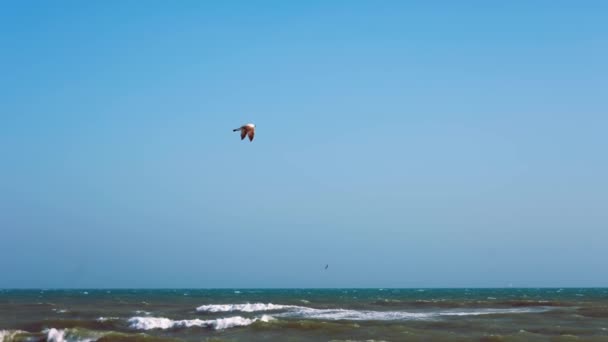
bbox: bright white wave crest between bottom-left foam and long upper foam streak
[128,315,274,330]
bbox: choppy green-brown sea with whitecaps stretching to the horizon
[0,288,608,342]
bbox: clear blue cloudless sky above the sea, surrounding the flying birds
[0,1,608,287]
